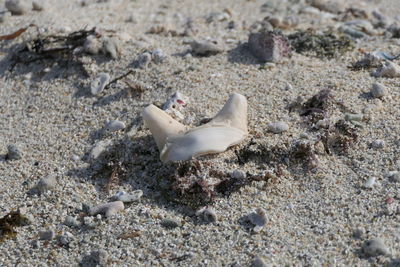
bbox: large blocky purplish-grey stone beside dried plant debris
[248,31,291,63]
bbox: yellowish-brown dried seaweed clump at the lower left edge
[0,210,30,242]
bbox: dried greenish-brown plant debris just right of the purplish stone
[287,31,353,58]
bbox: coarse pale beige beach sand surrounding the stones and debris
[0,0,400,266]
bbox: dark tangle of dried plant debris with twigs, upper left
[12,28,100,71]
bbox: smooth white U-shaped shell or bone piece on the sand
[143,94,247,162]
